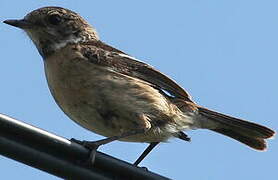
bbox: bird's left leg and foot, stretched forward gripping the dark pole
[71,129,147,164]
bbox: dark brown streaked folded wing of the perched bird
[82,41,192,102]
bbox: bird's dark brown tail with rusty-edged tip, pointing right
[198,107,275,151]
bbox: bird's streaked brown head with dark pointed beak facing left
[4,7,99,57]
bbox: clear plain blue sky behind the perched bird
[0,0,278,180]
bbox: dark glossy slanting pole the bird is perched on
[0,114,172,180]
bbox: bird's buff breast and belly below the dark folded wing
[45,54,192,142]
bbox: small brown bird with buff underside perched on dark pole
[4,6,275,166]
